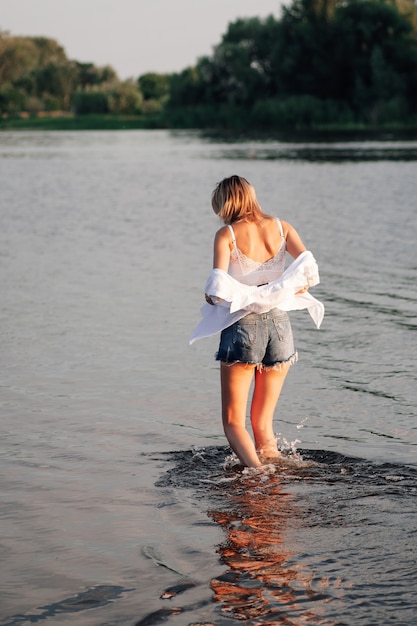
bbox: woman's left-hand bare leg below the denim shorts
[220,363,261,467]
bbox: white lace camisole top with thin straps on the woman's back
[228,218,286,286]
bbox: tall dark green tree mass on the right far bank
[169,0,417,126]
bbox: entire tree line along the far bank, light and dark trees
[0,0,417,130]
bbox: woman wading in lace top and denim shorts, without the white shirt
[206,176,308,467]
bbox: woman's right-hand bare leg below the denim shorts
[251,363,290,457]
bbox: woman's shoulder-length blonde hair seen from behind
[211,176,264,224]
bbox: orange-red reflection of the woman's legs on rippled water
[209,474,334,624]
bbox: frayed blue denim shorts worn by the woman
[216,309,297,367]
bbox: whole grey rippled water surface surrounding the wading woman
[0,131,417,626]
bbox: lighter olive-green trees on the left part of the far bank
[0,32,168,117]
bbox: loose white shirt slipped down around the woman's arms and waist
[190,250,324,344]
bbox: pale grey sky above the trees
[0,0,282,80]
